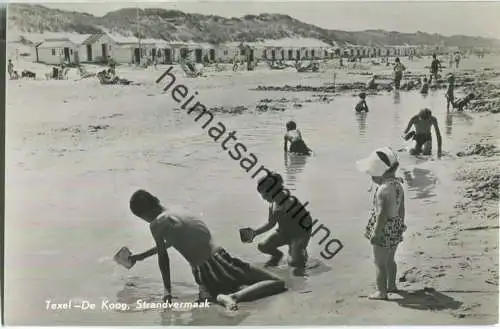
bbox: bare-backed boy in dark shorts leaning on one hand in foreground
[130,190,286,310]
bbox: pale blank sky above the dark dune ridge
[17,0,500,39]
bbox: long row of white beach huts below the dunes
[30,33,435,64]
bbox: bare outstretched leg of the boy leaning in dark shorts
[217,267,286,310]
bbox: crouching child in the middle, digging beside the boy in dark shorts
[246,173,313,276]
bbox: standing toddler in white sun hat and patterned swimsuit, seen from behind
[356,147,406,300]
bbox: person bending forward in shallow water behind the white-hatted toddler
[403,108,442,157]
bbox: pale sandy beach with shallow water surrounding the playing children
[5,50,500,325]
